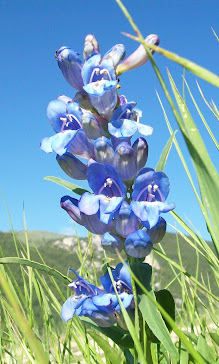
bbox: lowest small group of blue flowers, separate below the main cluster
[61,264,134,327]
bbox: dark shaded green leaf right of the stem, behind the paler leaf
[155,289,175,331]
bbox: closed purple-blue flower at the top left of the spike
[55,46,84,93]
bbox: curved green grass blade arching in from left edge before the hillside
[0,257,71,284]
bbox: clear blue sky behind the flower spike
[0,0,219,238]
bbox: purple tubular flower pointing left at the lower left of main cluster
[60,196,113,235]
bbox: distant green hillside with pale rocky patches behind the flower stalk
[0,231,217,322]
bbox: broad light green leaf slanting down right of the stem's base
[139,291,178,360]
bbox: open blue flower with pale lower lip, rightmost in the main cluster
[131,168,175,229]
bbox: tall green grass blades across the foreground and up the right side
[0,0,219,364]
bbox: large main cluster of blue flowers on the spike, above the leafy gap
[41,34,174,258]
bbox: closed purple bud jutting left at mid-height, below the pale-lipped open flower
[56,152,87,180]
